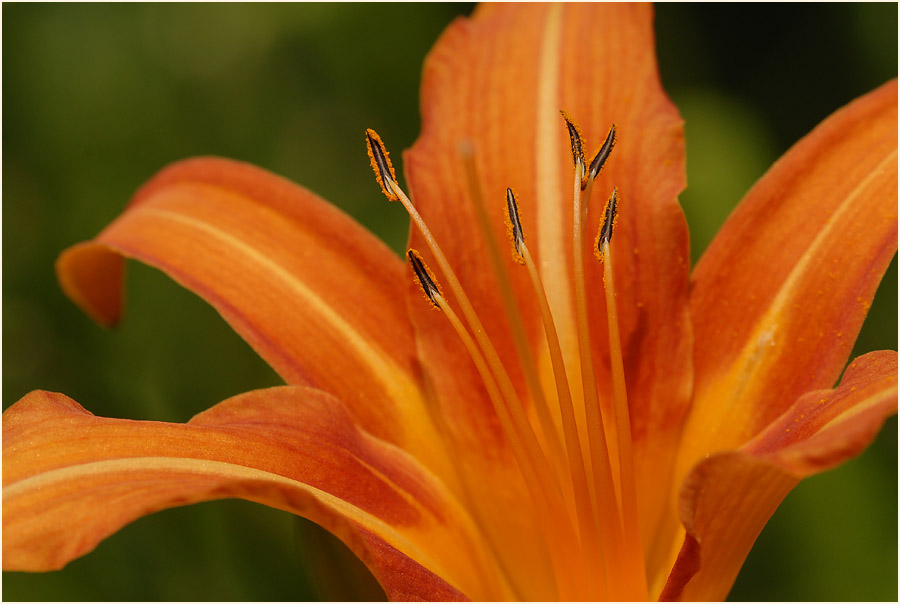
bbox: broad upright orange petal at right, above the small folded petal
[680,81,897,469]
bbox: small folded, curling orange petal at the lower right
[662,351,897,600]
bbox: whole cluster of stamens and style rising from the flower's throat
[366,117,648,600]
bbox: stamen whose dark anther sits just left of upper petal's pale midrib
[506,189,608,600]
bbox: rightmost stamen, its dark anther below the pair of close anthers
[596,189,644,596]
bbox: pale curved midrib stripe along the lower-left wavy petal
[3,457,447,579]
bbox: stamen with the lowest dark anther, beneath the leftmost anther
[407,250,585,600]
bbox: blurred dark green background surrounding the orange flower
[2,4,897,601]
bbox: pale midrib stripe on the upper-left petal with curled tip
[134,208,421,411]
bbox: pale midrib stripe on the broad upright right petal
[708,149,897,408]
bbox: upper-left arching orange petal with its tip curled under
[57,158,452,494]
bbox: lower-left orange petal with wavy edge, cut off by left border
[3,386,509,599]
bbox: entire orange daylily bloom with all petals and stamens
[3,4,897,600]
